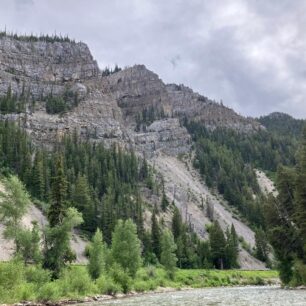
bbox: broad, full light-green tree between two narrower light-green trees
[111,219,142,277]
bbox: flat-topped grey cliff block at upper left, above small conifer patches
[0,37,99,99]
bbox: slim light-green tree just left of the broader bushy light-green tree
[87,229,105,279]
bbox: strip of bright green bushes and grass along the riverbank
[0,260,279,305]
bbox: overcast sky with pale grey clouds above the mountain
[0,0,306,118]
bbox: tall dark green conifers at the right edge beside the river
[265,123,306,284]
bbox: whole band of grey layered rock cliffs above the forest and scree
[0,37,259,155]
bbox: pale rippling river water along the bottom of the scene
[86,286,306,306]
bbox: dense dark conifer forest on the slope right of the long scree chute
[185,122,297,227]
